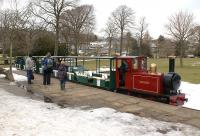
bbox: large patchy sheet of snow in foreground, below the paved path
[0,89,200,136]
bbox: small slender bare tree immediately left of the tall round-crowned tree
[104,18,117,56]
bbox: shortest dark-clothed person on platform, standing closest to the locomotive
[58,61,67,90]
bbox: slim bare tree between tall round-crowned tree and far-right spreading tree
[137,17,148,55]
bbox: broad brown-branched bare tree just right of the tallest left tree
[62,5,95,55]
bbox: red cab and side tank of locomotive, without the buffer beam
[116,57,163,94]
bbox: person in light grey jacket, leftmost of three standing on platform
[25,54,34,92]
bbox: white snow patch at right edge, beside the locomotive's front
[180,82,200,110]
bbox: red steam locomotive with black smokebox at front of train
[116,56,186,105]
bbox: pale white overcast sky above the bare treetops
[0,0,200,38]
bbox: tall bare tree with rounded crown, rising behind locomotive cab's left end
[112,5,134,55]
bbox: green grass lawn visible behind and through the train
[72,58,200,84]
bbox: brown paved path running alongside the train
[3,71,200,128]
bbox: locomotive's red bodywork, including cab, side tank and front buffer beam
[116,56,185,105]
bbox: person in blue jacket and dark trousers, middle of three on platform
[42,52,53,85]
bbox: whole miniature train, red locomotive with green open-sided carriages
[15,56,186,105]
